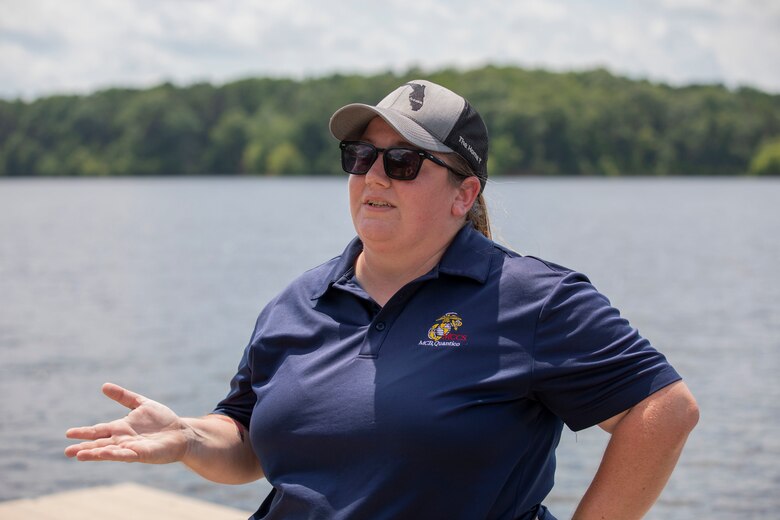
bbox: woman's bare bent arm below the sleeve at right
[573,382,699,520]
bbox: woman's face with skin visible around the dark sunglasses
[349,117,473,252]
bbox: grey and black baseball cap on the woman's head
[330,79,488,193]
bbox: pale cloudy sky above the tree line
[0,0,780,100]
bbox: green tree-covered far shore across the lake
[0,66,780,176]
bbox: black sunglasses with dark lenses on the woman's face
[339,141,452,181]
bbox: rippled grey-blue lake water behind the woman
[0,178,780,520]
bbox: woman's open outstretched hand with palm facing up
[65,383,193,464]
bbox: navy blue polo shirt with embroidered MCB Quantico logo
[215,226,680,520]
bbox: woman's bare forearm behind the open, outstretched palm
[181,414,263,484]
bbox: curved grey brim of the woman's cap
[329,103,453,152]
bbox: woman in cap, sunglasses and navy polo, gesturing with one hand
[66,80,698,519]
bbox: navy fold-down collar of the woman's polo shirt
[311,224,496,300]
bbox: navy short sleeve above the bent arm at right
[531,272,680,431]
